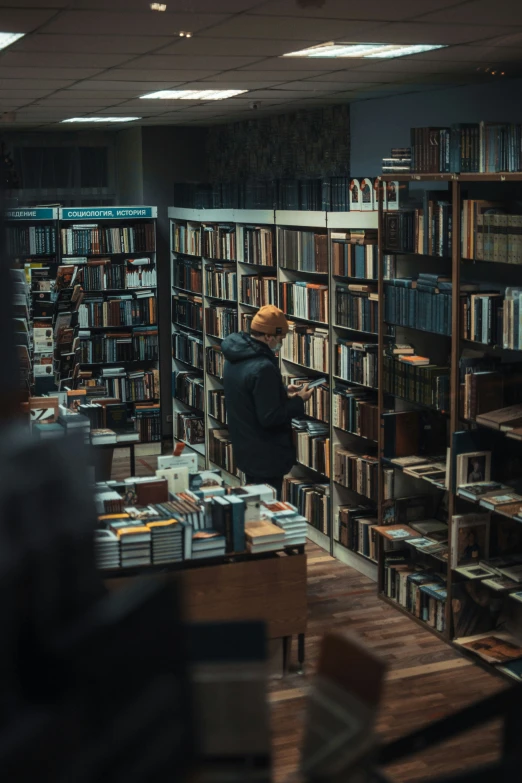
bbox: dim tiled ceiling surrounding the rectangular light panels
[0,0,522,131]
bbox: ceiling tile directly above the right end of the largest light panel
[366,22,508,44]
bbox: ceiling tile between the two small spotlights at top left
[41,10,226,36]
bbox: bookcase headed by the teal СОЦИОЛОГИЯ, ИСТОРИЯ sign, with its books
[59,206,161,443]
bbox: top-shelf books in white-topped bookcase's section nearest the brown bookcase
[331,229,378,280]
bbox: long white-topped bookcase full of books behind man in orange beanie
[169,208,378,568]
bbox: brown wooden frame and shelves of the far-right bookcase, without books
[378,172,522,670]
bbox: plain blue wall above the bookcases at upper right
[350,77,522,177]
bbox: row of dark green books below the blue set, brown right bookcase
[383,356,450,412]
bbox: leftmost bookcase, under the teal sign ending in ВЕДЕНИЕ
[5,207,60,394]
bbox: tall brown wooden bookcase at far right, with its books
[374,173,522,680]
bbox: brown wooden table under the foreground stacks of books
[105,547,307,670]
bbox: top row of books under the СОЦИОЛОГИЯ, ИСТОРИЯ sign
[60,223,156,256]
